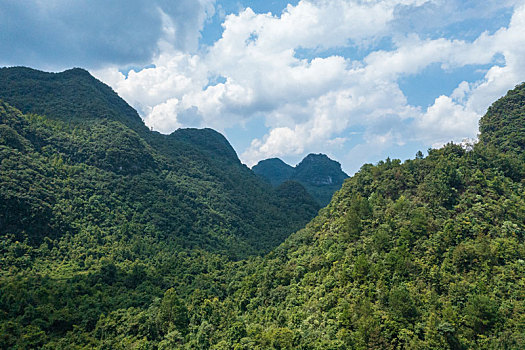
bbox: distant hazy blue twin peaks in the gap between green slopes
[252,154,348,206]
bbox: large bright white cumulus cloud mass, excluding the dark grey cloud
[91,0,525,170]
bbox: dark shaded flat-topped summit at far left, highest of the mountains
[0,67,147,132]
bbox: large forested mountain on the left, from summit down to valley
[0,68,319,348]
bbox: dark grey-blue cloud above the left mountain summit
[0,0,215,70]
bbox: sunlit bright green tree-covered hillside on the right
[171,85,525,349]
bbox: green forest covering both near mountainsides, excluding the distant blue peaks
[0,67,525,350]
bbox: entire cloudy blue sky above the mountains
[0,0,525,174]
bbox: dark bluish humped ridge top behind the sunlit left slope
[0,67,244,167]
